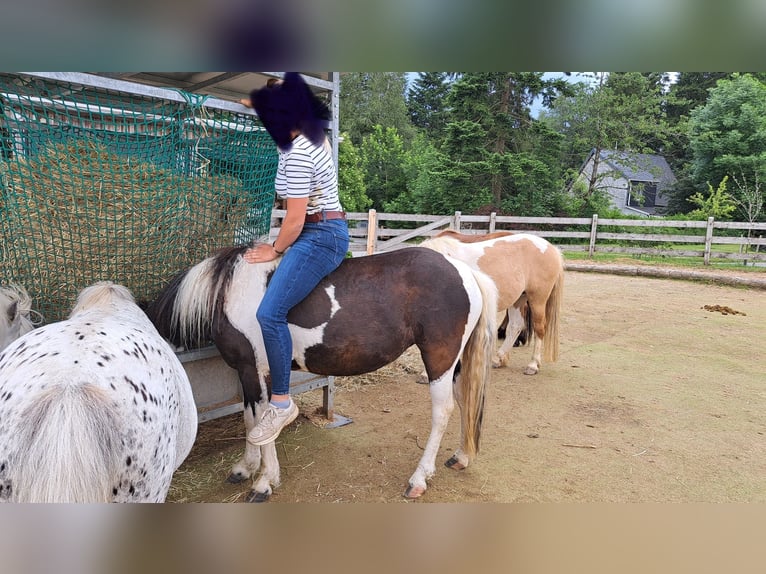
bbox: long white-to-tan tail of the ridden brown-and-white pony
[456,271,497,461]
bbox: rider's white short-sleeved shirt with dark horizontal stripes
[274,135,343,215]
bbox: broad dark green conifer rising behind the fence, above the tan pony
[440,72,569,212]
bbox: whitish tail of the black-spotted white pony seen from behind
[11,383,123,503]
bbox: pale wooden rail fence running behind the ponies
[271,209,766,265]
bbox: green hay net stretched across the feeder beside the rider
[0,74,277,323]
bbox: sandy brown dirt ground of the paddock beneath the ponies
[168,271,766,504]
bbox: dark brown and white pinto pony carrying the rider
[147,247,497,502]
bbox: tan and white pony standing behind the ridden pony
[421,230,564,375]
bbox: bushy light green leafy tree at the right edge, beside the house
[689,74,766,216]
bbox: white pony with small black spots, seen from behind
[0,282,197,502]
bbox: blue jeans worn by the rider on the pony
[256,219,348,395]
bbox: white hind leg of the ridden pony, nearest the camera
[404,369,455,498]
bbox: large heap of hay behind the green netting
[0,140,264,321]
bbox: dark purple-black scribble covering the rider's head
[250,72,332,150]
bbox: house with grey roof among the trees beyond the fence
[578,150,676,216]
